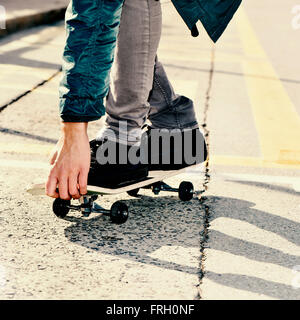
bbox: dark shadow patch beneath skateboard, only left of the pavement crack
[65,196,202,274]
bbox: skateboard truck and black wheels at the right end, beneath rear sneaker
[127,181,195,201]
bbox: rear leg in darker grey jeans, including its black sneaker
[147,60,207,170]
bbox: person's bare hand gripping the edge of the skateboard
[45,123,90,200]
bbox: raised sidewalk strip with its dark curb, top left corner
[0,0,69,38]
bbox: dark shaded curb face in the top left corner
[0,7,66,39]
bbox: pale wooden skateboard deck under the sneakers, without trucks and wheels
[27,164,198,196]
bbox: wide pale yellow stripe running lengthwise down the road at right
[237,8,300,165]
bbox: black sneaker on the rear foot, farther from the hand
[142,127,207,171]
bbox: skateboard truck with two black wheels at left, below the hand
[52,195,128,224]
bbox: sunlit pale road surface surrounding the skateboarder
[0,0,300,299]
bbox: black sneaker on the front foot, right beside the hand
[88,140,148,188]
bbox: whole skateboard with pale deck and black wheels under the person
[27,165,197,224]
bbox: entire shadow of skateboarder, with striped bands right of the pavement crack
[65,184,300,299]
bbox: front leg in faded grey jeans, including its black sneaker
[89,0,162,186]
